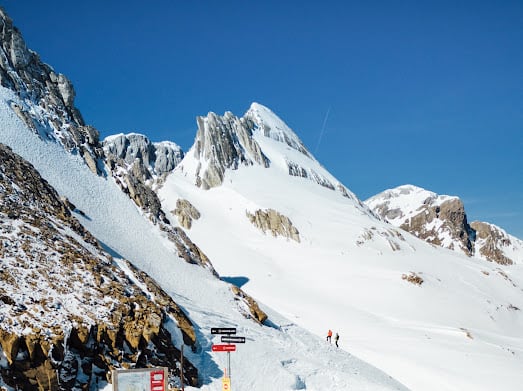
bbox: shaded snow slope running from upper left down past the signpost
[0,88,405,390]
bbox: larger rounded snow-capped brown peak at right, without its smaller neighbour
[365,185,474,255]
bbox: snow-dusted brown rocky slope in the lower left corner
[0,144,198,390]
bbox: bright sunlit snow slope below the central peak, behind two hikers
[159,105,523,391]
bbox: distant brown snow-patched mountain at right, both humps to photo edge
[365,185,523,265]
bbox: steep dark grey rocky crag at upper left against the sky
[0,8,101,173]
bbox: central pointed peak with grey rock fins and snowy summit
[184,103,357,200]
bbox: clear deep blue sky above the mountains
[4,0,523,238]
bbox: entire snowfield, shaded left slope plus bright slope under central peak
[0,88,523,391]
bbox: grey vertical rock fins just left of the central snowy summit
[193,112,269,189]
